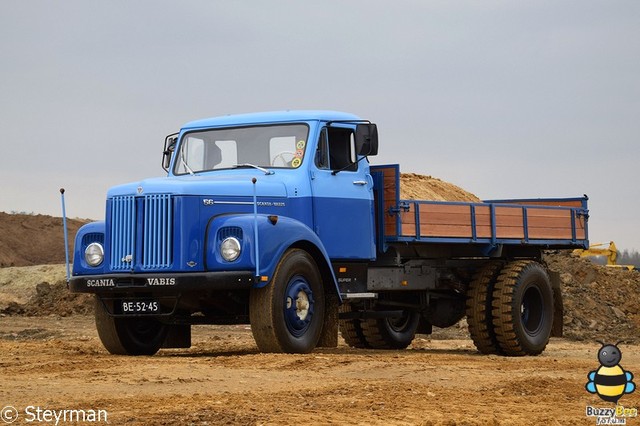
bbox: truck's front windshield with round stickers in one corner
[173,124,309,175]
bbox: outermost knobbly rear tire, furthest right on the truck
[492,260,553,356]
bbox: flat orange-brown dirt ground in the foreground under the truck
[0,315,640,425]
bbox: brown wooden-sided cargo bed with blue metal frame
[371,164,588,248]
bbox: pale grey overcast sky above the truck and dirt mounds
[0,0,640,250]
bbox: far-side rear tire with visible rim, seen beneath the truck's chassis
[361,311,420,349]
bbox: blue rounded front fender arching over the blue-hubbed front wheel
[204,214,338,292]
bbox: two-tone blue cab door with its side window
[310,125,376,260]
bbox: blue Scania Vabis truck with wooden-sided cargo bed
[69,111,589,356]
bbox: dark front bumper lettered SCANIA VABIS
[69,271,256,294]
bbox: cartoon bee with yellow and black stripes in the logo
[585,340,636,404]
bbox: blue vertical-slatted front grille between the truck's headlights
[110,194,173,271]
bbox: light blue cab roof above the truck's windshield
[182,110,362,129]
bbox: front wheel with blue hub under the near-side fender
[249,249,325,353]
